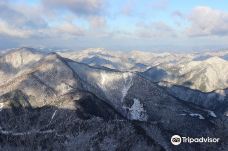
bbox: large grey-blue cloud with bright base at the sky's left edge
[0,1,84,39]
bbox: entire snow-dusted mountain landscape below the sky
[0,48,228,151]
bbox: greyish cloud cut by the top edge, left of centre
[42,0,105,16]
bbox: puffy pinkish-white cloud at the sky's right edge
[186,6,228,36]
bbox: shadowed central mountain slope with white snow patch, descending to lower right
[62,56,228,149]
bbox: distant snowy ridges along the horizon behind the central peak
[59,48,190,71]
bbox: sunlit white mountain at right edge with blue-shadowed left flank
[144,57,228,92]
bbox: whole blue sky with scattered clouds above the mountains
[0,0,228,52]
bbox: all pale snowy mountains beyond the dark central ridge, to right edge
[59,48,228,92]
